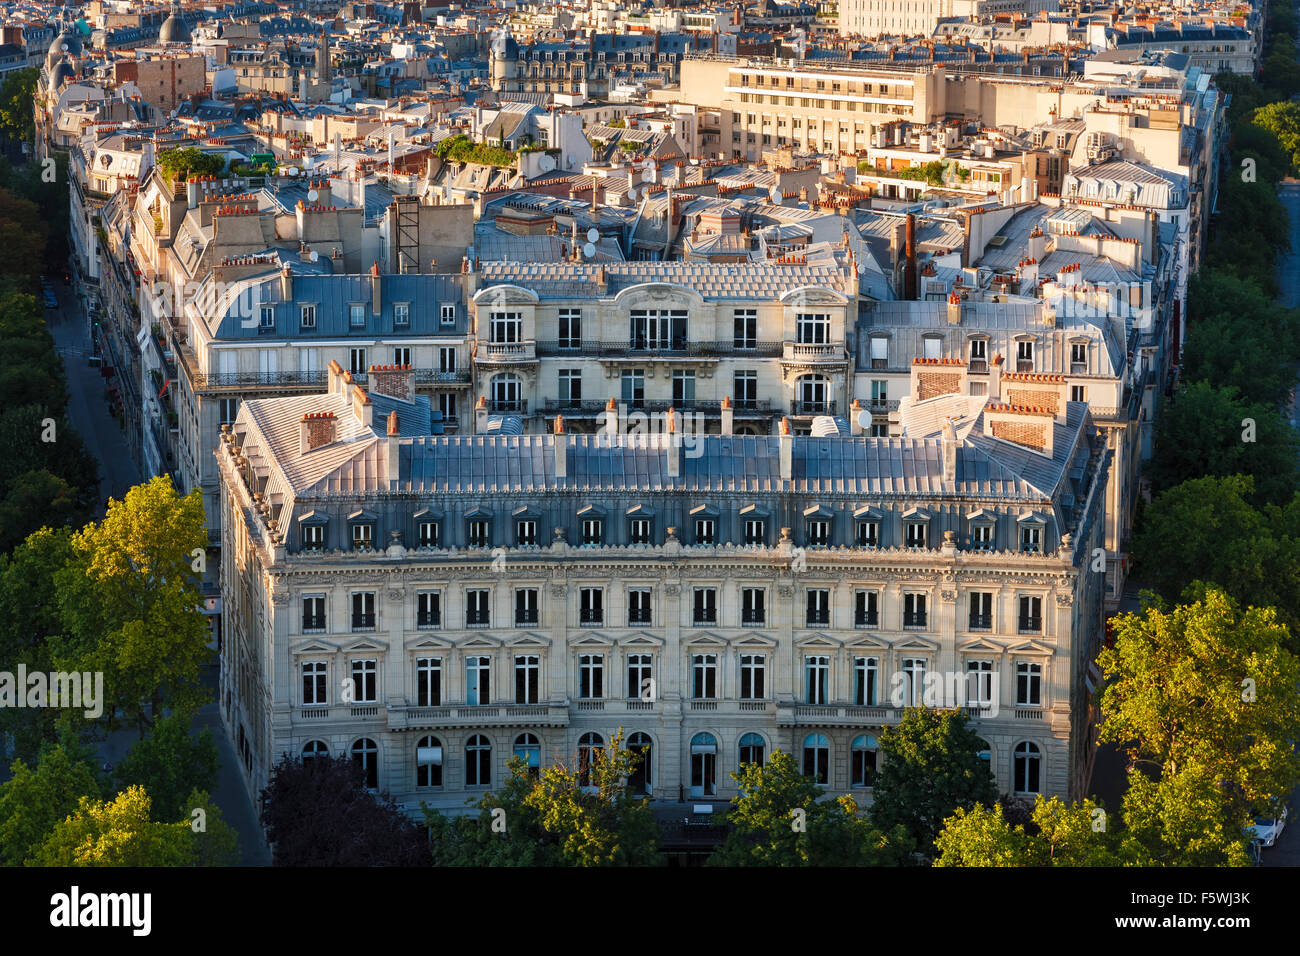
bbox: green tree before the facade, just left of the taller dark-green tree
[709,750,911,866]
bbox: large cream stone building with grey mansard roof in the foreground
[216,364,1108,813]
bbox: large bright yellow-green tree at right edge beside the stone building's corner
[1097,588,1300,831]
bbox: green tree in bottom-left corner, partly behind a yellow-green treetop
[0,745,100,866]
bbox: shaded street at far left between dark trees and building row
[46,282,142,516]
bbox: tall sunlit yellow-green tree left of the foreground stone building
[55,476,212,739]
